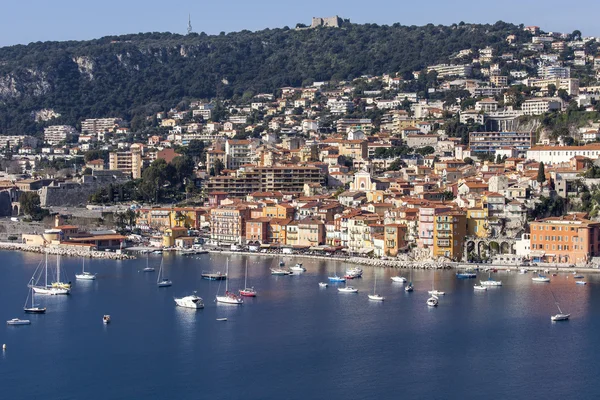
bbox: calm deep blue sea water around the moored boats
[0,252,600,400]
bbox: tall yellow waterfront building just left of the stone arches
[433,211,467,261]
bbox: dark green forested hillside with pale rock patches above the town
[0,22,528,134]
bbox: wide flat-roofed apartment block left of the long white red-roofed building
[469,132,535,155]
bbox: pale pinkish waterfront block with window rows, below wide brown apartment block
[210,205,250,245]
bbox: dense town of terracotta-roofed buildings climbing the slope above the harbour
[0,19,600,266]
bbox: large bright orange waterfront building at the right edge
[530,215,600,264]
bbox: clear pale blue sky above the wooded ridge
[0,0,600,47]
